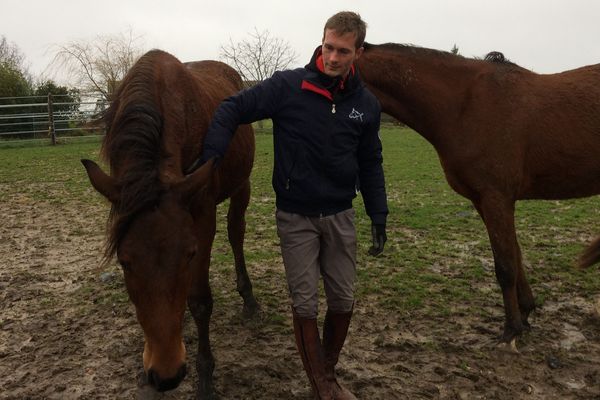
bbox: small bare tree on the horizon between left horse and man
[220,28,298,85]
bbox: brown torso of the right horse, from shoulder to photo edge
[446,65,600,199]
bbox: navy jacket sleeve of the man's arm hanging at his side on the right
[358,102,388,224]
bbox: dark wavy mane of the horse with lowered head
[99,51,164,262]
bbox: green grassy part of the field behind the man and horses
[0,126,600,322]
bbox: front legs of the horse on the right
[476,196,531,343]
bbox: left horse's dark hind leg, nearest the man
[227,181,259,317]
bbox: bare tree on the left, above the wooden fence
[51,30,144,100]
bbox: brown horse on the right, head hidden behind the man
[358,44,600,345]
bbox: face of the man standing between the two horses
[322,29,363,78]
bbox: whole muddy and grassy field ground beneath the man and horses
[0,126,600,400]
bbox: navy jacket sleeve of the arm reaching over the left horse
[201,72,282,161]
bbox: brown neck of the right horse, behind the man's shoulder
[361,47,477,145]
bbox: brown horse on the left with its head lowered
[82,50,258,399]
